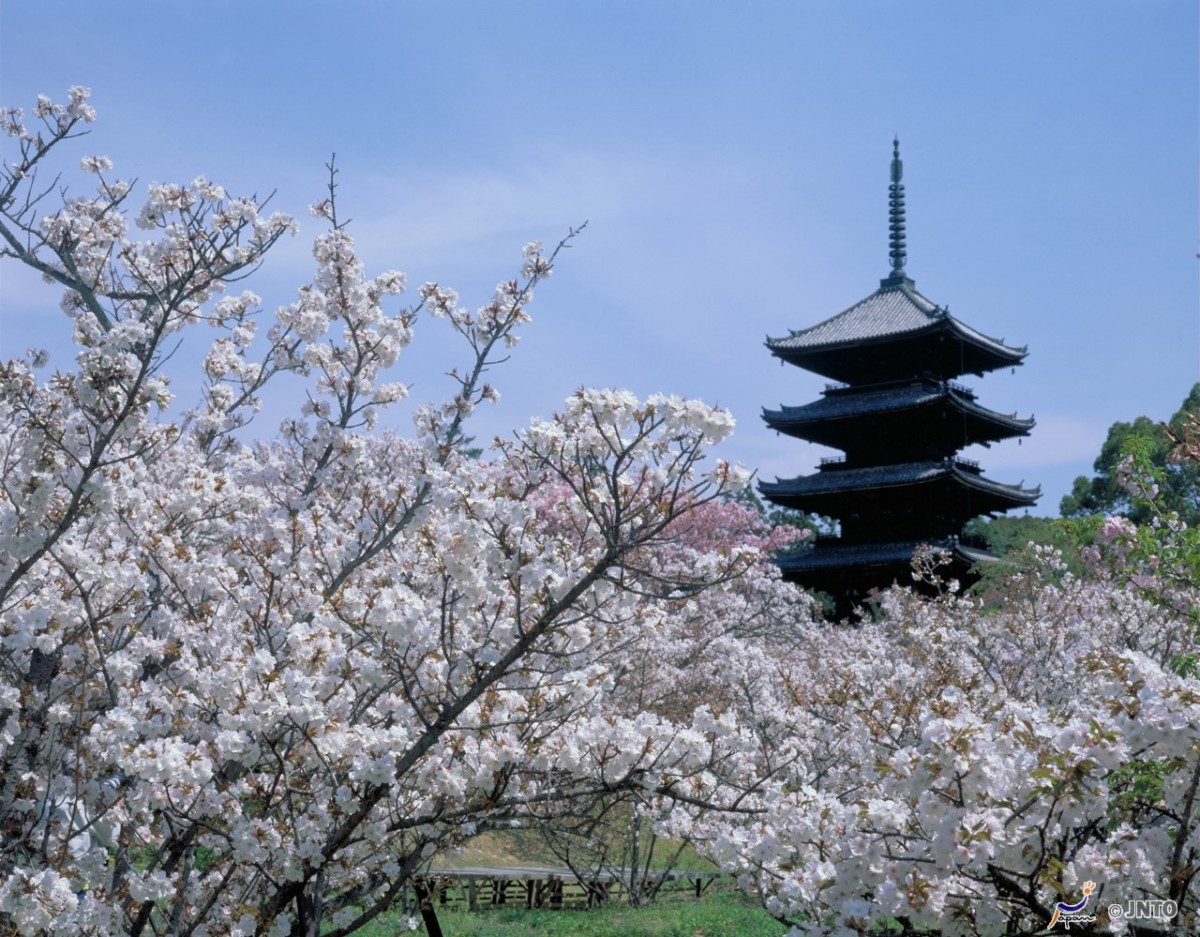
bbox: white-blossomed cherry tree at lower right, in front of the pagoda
[686,529,1200,937]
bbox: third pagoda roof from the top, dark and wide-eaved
[758,458,1042,517]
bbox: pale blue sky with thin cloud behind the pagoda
[0,0,1200,515]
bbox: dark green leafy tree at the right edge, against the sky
[1060,384,1200,525]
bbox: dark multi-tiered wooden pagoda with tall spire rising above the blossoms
[758,139,1040,614]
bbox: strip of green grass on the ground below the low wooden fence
[350,891,786,937]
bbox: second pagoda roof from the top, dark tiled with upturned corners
[762,380,1034,448]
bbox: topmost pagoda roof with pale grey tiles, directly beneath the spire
[767,276,1028,380]
